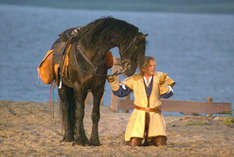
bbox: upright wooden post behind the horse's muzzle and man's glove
[110,57,120,112]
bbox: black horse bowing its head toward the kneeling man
[52,17,147,146]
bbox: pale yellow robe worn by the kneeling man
[110,72,174,142]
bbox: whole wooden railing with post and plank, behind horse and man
[110,58,232,114]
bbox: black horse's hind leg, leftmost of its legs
[58,85,75,142]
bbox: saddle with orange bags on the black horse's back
[37,27,113,86]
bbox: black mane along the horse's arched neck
[81,17,138,49]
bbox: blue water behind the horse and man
[0,5,234,115]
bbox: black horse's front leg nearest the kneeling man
[89,86,104,146]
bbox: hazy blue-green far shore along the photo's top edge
[0,0,234,14]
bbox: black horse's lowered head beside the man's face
[120,32,148,76]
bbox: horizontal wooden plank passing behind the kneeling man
[119,99,232,114]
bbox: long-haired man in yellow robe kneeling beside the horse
[107,57,175,146]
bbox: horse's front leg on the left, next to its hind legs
[74,85,88,145]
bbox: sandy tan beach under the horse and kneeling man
[0,101,234,157]
